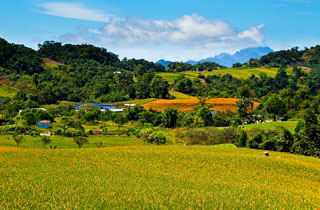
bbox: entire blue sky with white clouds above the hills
[0,0,320,61]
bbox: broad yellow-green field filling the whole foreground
[0,146,320,209]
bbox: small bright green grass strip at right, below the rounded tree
[244,121,298,133]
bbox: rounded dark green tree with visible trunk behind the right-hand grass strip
[265,94,286,121]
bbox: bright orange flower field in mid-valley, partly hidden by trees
[143,98,259,112]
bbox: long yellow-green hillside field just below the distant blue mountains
[159,68,292,84]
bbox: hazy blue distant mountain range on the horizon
[157,47,274,67]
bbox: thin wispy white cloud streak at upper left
[38,2,112,22]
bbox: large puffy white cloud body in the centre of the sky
[102,14,233,44]
